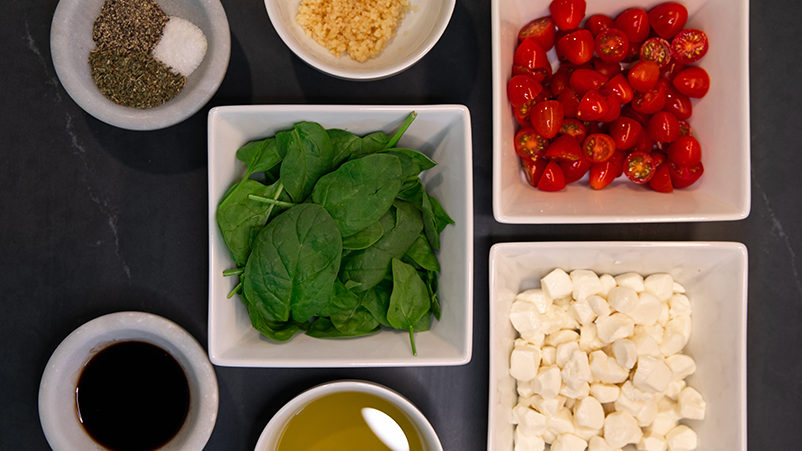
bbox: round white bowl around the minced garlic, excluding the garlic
[265,0,456,81]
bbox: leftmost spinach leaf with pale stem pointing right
[216,179,282,266]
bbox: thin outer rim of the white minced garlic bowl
[264,0,456,81]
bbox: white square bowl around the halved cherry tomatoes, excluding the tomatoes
[491,0,750,224]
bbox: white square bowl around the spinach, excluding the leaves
[208,105,473,367]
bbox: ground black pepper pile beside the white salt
[92,0,168,53]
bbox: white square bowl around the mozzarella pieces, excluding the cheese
[487,242,747,451]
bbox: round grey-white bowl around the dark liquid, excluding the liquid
[39,312,218,451]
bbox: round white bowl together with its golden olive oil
[255,380,443,451]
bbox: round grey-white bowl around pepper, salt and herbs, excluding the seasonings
[50,0,231,130]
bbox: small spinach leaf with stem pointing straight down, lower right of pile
[387,258,431,355]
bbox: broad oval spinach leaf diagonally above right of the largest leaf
[312,154,401,236]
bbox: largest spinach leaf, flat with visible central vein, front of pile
[242,204,342,323]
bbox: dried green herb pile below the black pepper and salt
[89,49,187,109]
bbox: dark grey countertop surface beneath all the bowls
[0,0,802,450]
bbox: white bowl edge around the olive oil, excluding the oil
[254,380,443,451]
